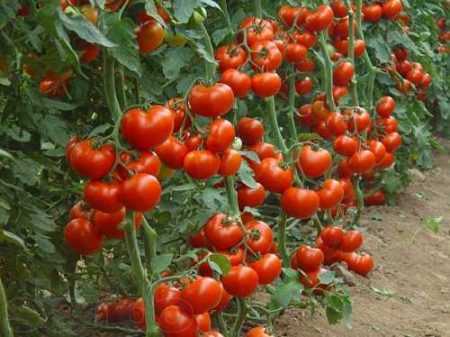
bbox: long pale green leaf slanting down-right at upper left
[57,6,116,47]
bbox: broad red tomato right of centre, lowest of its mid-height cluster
[281,187,320,219]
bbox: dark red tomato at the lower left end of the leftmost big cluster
[64,218,103,255]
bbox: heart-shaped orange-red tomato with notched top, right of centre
[297,145,332,178]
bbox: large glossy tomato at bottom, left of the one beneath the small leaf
[181,277,222,315]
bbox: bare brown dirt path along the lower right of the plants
[277,138,450,337]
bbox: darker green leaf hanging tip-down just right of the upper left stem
[107,15,141,74]
